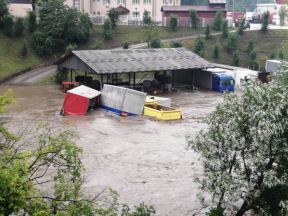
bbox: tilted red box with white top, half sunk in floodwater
[63,85,101,115]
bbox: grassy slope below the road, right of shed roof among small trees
[177,30,288,69]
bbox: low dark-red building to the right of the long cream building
[162,0,227,27]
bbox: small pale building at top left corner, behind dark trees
[8,0,32,17]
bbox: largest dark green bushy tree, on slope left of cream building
[33,0,92,55]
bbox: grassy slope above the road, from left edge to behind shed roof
[0,26,203,80]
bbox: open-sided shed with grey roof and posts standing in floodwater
[57,48,214,88]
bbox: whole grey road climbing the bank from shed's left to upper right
[5,24,288,84]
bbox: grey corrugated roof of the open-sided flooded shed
[58,48,213,74]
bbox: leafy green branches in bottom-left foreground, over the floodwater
[0,91,155,216]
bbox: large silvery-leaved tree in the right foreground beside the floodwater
[189,67,288,216]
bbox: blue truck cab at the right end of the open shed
[212,72,235,92]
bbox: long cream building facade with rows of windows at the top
[66,0,181,22]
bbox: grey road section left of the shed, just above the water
[4,65,57,84]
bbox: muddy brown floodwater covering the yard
[0,86,222,216]
